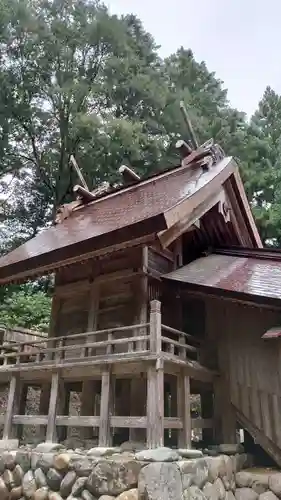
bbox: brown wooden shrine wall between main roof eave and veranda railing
[50,246,173,340]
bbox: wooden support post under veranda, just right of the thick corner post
[177,371,191,448]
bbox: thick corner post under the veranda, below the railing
[147,360,164,448]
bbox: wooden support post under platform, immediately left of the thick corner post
[99,368,111,446]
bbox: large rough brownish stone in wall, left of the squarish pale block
[87,460,142,496]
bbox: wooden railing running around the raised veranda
[0,301,198,370]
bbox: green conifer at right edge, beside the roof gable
[241,87,281,246]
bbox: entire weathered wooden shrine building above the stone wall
[0,143,281,463]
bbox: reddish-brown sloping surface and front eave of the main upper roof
[0,158,237,284]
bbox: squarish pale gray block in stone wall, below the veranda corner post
[138,463,183,500]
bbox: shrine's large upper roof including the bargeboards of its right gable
[0,157,260,284]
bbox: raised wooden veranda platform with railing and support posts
[0,301,215,447]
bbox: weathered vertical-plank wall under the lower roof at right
[205,299,281,462]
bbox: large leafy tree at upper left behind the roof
[0,0,166,244]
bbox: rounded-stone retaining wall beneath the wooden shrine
[0,443,276,500]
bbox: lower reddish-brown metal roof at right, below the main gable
[164,250,281,300]
